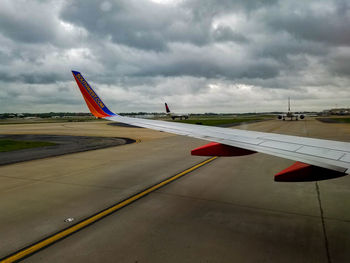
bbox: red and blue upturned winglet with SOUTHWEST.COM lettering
[72,70,116,118]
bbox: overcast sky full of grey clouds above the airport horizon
[0,0,350,112]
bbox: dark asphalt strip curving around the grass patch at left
[0,134,135,165]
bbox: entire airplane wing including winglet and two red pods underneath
[72,71,350,182]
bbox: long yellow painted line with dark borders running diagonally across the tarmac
[1,156,217,263]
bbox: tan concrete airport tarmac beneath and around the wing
[0,119,350,262]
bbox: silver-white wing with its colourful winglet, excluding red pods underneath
[72,71,350,176]
